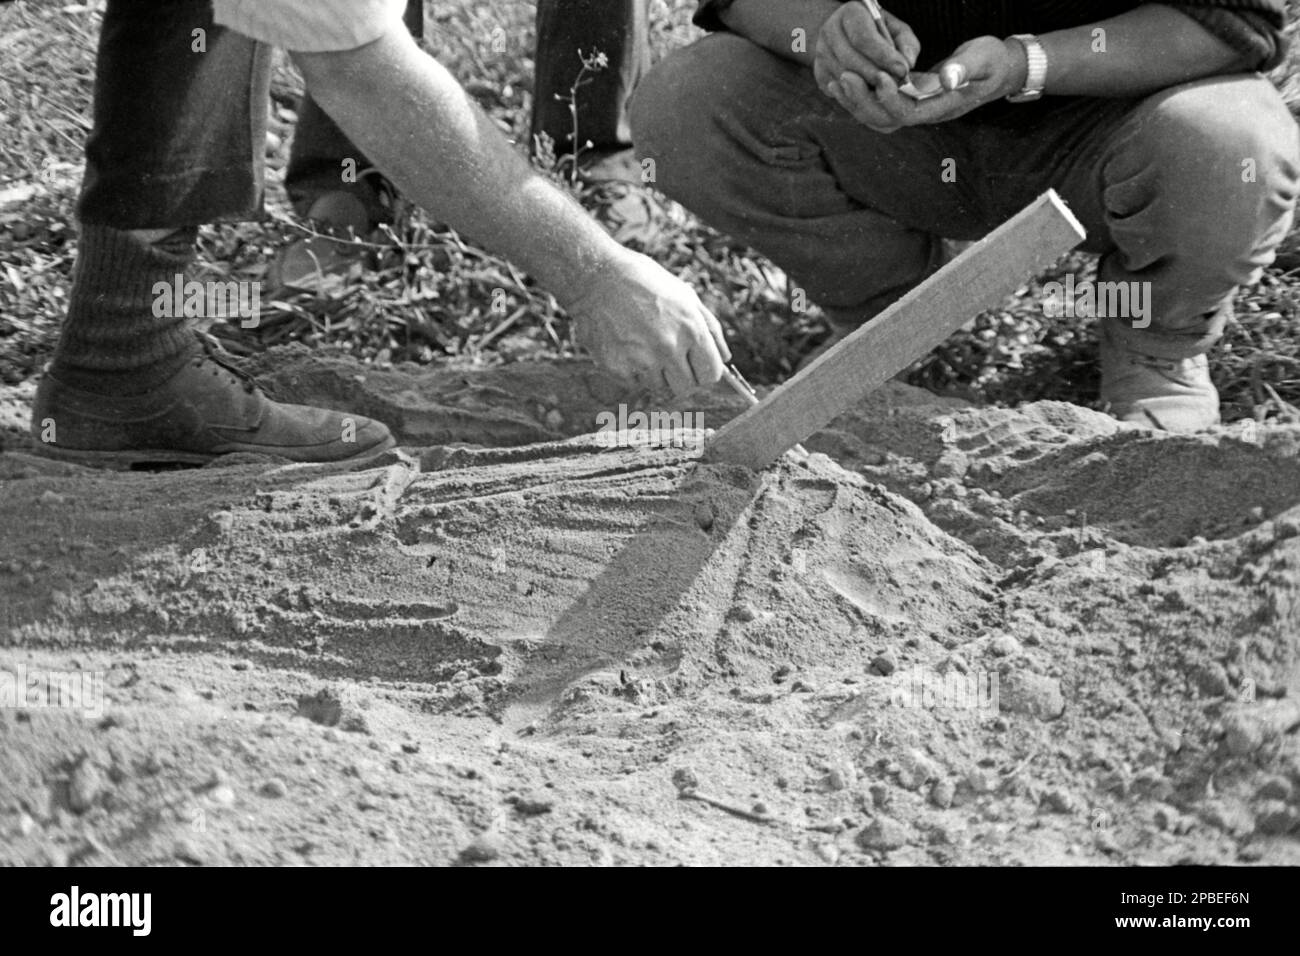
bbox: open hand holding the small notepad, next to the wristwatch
[836,36,1027,133]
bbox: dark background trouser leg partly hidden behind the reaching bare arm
[285,0,424,220]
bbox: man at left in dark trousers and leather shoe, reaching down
[33,0,729,467]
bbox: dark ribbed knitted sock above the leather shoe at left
[51,225,200,395]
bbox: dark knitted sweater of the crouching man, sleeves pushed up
[696,0,1286,69]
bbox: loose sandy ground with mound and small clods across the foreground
[0,350,1300,865]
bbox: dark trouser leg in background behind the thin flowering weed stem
[532,0,650,155]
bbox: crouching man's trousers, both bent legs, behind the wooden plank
[633,34,1300,358]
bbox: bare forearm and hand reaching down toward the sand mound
[294,29,728,393]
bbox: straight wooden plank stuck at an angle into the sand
[705,190,1087,471]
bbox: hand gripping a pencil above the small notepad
[813,3,920,131]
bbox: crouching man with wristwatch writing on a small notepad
[632,0,1300,432]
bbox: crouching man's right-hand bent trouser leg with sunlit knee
[1049,74,1300,358]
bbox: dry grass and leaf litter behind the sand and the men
[0,0,1300,418]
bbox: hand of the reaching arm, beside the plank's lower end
[563,250,731,395]
